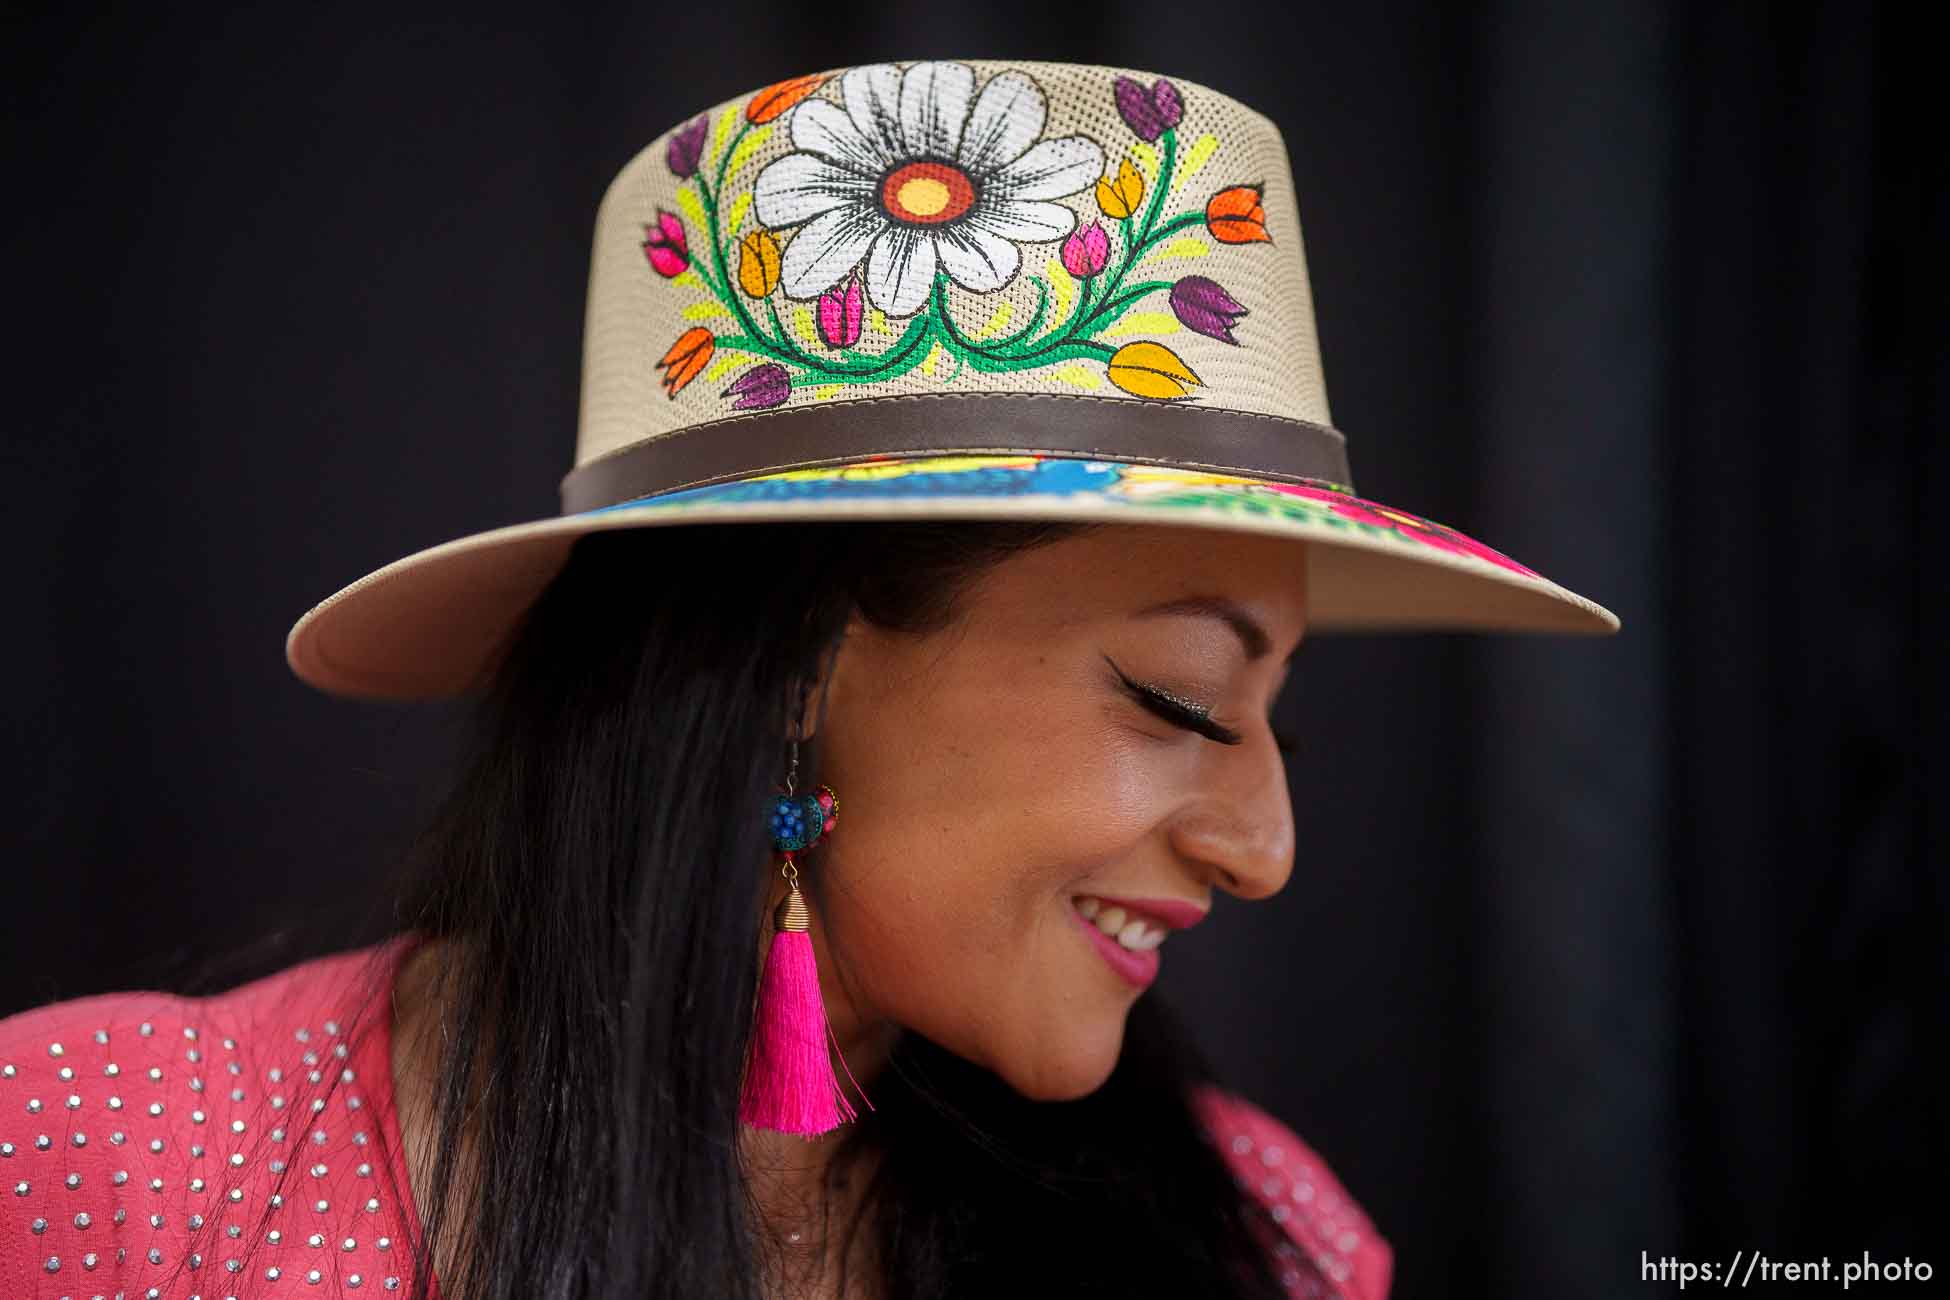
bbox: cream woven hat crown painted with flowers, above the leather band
[575,58,1332,485]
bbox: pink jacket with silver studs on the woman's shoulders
[0,936,1394,1300]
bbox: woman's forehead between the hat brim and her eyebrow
[947,524,1307,639]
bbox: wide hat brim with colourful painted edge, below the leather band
[285,454,1619,700]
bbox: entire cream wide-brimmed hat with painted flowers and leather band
[287,58,1619,698]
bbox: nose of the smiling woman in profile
[1170,731,1293,899]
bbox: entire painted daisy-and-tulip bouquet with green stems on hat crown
[644,62,1271,411]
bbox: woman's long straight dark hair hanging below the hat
[205,520,1285,1300]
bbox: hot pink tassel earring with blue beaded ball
[739,741,874,1138]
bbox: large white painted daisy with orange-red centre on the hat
[753,62,1104,316]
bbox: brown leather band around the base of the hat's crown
[562,394,1353,515]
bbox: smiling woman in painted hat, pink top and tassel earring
[0,62,1617,1300]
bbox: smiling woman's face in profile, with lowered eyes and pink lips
[760,526,1307,1101]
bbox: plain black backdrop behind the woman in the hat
[0,0,1950,1296]
